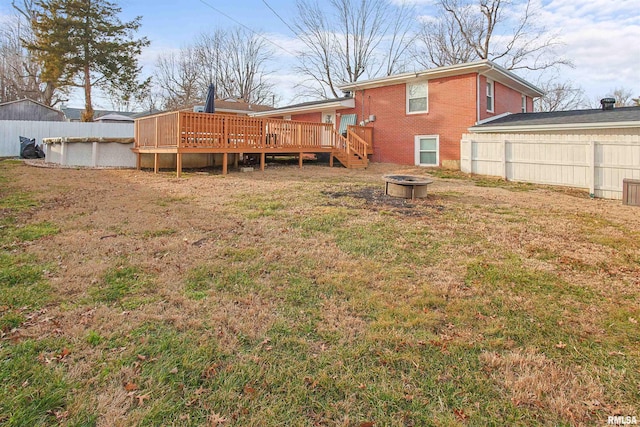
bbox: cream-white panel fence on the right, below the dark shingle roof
[460,133,640,199]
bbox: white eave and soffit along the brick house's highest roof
[340,60,544,98]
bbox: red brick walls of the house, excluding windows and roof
[292,73,531,165]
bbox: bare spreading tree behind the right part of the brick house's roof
[421,0,570,71]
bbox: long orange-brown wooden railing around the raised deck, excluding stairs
[135,111,340,151]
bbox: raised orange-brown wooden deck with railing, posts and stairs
[133,111,373,176]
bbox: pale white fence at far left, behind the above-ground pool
[0,120,133,157]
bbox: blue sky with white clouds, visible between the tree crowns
[0,0,640,107]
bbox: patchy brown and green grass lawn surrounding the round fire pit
[0,161,640,427]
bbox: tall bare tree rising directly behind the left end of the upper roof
[295,0,414,98]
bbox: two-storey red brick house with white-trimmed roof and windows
[253,61,543,169]
